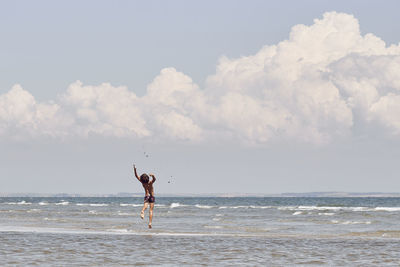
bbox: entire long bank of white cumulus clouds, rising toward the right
[0,12,400,144]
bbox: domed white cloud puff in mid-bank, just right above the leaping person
[141,68,204,141]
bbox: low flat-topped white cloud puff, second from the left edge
[61,81,151,138]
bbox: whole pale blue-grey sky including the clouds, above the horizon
[0,0,400,194]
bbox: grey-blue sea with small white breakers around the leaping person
[0,197,400,266]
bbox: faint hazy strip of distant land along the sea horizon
[0,192,400,198]
